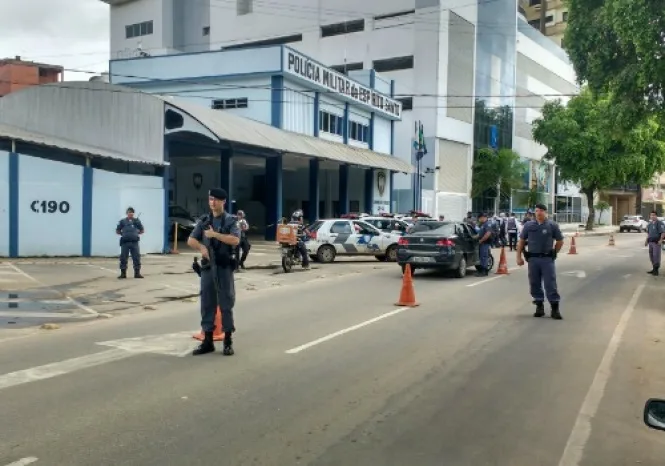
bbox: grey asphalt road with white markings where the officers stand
[0,235,665,466]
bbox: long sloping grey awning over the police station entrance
[162,97,414,173]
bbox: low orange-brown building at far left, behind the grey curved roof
[0,57,64,97]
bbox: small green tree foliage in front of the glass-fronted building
[471,148,525,197]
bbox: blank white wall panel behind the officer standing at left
[91,169,164,256]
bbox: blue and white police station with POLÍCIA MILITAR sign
[0,46,412,257]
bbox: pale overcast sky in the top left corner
[0,0,109,81]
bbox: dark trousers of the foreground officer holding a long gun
[201,267,236,333]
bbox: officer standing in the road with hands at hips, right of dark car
[517,204,563,320]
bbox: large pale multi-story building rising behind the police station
[102,0,574,217]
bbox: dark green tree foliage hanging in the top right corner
[563,0,665,122]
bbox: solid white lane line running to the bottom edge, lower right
[559,284,645,466]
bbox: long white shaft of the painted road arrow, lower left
[0,348,135,390]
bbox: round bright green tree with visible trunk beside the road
[533,89,665,230]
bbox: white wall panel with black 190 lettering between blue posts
[18,154,83,256]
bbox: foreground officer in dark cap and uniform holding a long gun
[187,188,240,356]
